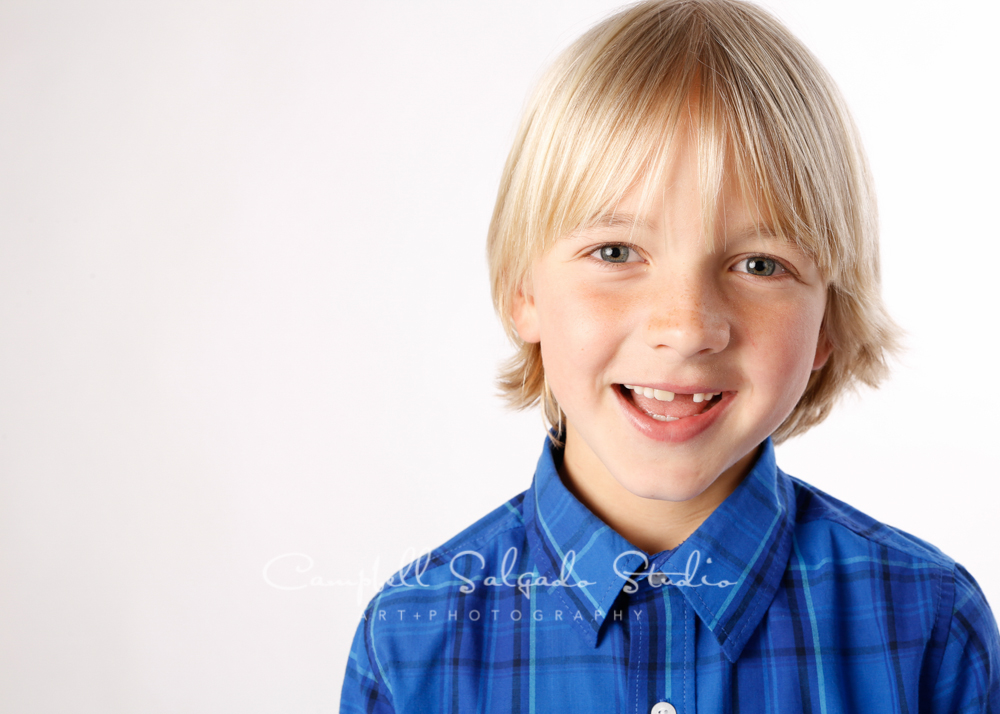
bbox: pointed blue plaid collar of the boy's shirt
[524,438,795,662]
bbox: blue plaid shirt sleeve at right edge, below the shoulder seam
[921,564,1000,714]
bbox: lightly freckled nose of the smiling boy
[645,280,730,359]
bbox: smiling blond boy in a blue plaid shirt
[341,0,1000,714]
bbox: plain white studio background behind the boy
[0,0,1000,714]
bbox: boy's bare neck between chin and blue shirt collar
[556,428,759,554]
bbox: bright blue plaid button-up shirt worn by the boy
[341,439,1000,714]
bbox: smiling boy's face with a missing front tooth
[514,131,830,501]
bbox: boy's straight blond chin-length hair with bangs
[487,0,899,442]
